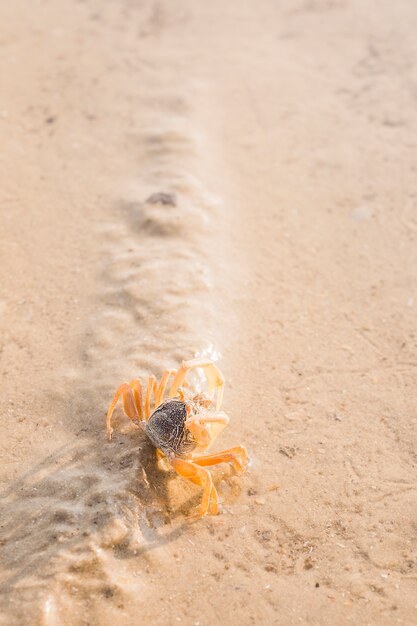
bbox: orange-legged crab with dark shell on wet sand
[107,358,247,517]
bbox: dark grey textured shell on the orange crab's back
[145,400,197,458]
